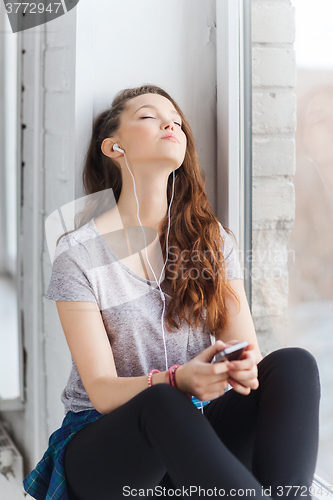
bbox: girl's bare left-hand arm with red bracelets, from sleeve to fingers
[56,301,233,414]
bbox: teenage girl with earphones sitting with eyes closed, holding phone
[24,85,320,500]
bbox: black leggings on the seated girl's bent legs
[65,347,320,500]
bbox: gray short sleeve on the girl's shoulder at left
[45,235,97,302]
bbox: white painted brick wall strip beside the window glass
[252,0,296,355]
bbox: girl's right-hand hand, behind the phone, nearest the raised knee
[228,340,259,395]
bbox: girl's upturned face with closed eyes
[114,94,186,171]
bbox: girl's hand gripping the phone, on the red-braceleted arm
[176,340,230,401]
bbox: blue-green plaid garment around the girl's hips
[23,410,103,500]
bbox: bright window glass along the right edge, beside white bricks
[288,0,333,484]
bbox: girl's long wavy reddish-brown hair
[76,84,239,335]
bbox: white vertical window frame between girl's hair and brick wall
[216,0,252,310]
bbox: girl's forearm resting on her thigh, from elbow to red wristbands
[89,371,166,414]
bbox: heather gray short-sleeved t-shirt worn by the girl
[45,219,243,414]
